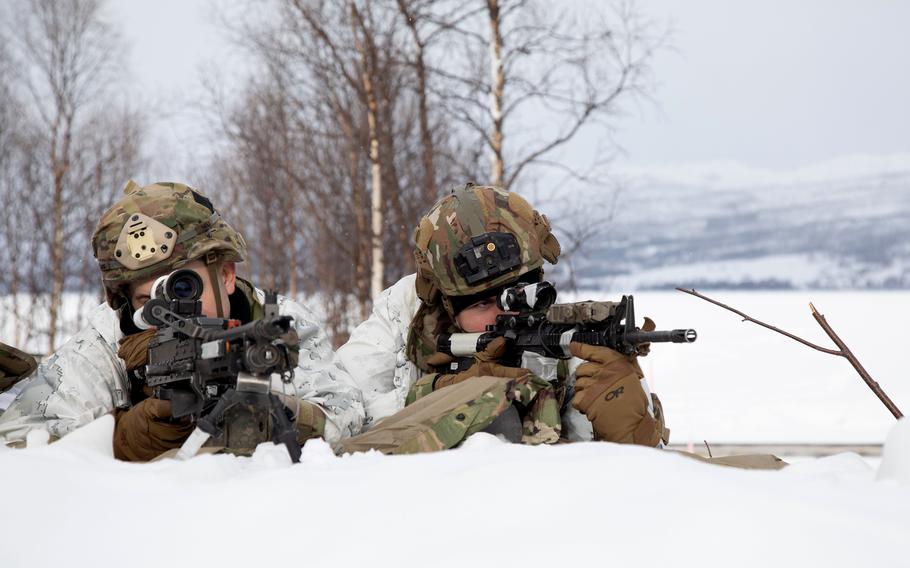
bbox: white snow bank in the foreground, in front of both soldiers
[0,432,910,568]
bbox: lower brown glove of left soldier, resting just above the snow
[114,398,194,461]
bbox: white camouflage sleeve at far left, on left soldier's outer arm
[0,327,125,444]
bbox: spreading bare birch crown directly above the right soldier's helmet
[432,0,666,188]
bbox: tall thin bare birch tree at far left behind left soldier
[3,0,141,349]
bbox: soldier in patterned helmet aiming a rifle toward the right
[337,184,669,453]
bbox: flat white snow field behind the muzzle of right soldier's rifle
[560,291,910,447]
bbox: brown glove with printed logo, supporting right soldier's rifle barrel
[569,342,665,446]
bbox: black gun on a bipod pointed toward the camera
[134,269,300,462]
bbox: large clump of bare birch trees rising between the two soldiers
[213,0,660,341]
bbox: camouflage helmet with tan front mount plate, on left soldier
[92,180,246,309]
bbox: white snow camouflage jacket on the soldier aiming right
[336,274,653,441]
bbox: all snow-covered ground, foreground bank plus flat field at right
[0,292,910,568]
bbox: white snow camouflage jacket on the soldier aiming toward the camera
[0,288,364,443]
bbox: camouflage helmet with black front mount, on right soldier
[414,183,560,315]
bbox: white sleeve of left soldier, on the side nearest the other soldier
[279,292,363,443]
